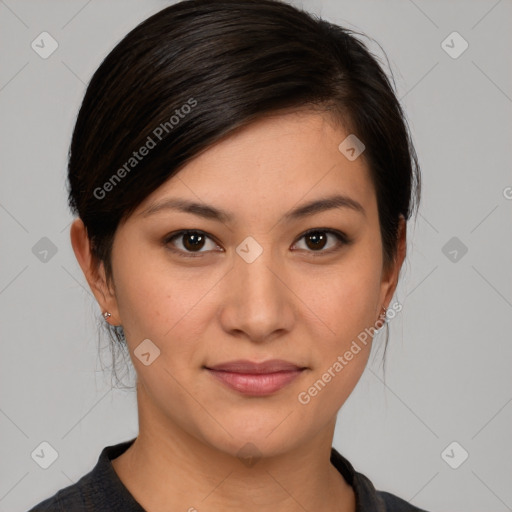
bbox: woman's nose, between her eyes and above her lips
[220,243,298,343]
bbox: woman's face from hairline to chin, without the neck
[75,112,404,455]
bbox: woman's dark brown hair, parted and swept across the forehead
[68,0,421,386]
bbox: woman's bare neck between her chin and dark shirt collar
[112,380,355,512]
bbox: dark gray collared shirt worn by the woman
[28,438,426,512]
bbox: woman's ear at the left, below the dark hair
[70,218,121,325]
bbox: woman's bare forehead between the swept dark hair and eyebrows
[134,112,376,224]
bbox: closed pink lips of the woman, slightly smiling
[206,359,305,396]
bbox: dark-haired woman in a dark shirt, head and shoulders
[28,0,428,512]
